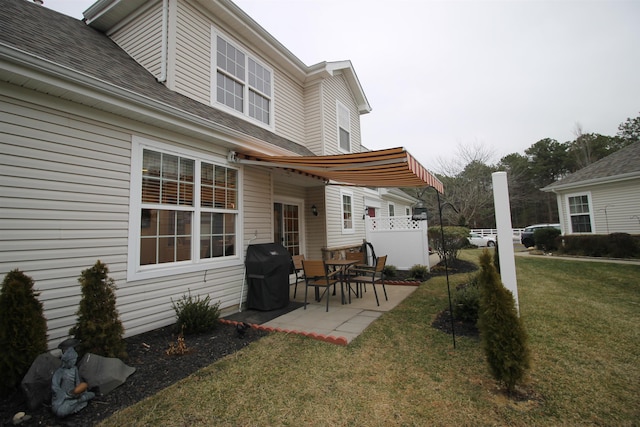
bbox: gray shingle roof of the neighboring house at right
[542,142,640,191]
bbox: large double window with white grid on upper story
[214,34,273,125]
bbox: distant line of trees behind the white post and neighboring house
[406,112,640,228]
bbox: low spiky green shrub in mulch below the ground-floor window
[171,293,220,335]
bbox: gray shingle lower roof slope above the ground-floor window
[0,0,313,155]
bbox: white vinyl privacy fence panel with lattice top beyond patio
[365,216,431,270]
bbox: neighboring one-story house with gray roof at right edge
[542,142,640,234]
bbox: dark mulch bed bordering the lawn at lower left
[0,323,267,426]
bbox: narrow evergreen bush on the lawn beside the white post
[478,250,530,393]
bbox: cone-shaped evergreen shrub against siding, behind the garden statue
[69,261,127,359]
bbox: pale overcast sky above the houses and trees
[45,0,640,172]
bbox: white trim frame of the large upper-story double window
[209,26,276,130]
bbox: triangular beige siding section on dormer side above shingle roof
[109,2,162,78]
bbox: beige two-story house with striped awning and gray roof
[0,0,442,346]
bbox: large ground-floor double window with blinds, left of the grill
[130,140,239,280]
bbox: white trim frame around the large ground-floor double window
[127,135,244,282]
